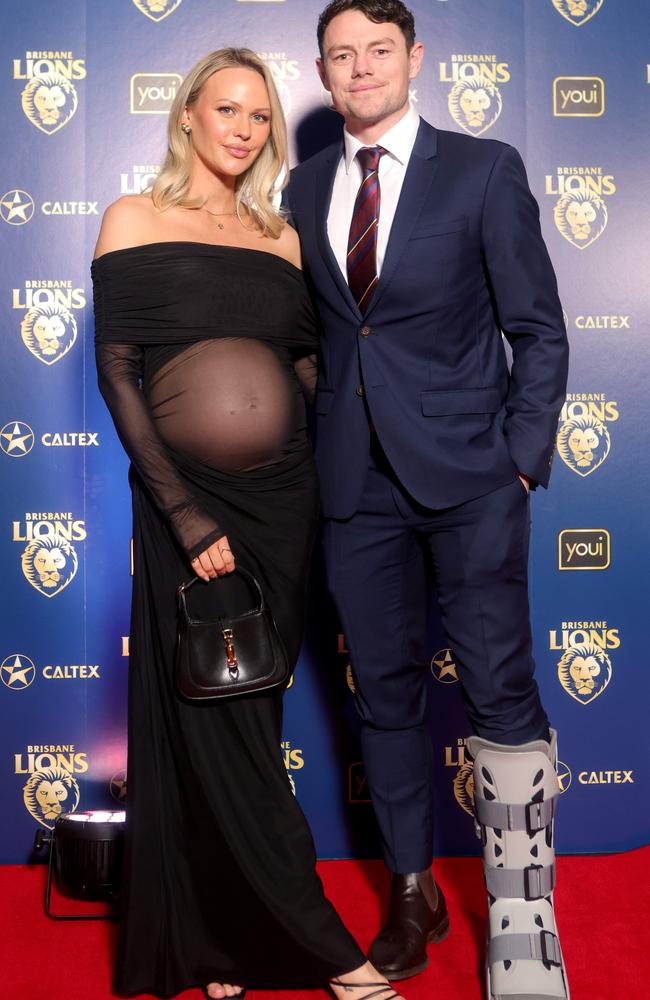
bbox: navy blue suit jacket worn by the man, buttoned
[286,121,568,518]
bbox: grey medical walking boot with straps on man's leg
[467,730,569,1000]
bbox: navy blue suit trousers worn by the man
[324,435,549,873]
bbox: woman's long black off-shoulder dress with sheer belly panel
[92,242,365,996]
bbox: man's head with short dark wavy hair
[316,10,424,131]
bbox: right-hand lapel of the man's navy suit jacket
[366,121,438,316]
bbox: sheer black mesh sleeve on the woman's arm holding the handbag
[95,343,223,560]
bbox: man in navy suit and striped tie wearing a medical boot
[287,0,568,1000]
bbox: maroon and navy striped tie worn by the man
[347,146,386,313]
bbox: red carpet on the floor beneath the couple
[0,847,650,1000]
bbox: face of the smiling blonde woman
[182,66,271,177]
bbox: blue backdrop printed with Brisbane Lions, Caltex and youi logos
[0,0,650,862]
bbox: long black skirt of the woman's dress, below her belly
[115,453,365,997]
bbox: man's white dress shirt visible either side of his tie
[327,105,420,281]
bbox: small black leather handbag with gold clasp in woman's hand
[175,567,289,701]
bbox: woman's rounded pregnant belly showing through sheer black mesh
[147,338,296,471]
